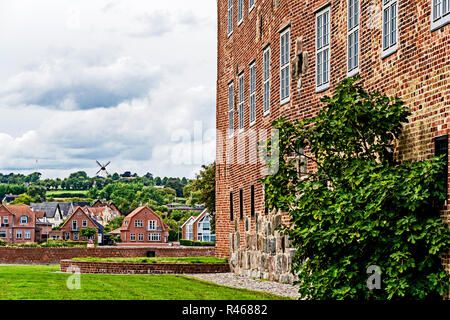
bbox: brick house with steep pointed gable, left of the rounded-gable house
[59,207,104,243]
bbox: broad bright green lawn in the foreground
[0,265,288,300]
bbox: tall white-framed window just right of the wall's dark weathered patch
[316,6,330,92]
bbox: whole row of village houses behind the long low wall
[0,201,215,246]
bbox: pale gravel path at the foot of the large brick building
[187,273,300,299]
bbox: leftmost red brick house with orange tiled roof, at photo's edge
[0,205,44,243]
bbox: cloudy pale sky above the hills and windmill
[0,0,216,178]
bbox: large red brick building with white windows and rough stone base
[216,0,450,282]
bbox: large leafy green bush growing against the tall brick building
[264,78,450,300]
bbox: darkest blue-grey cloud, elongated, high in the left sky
[0,57,162,110]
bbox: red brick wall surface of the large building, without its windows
[216,0,450,257]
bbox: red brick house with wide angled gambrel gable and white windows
[119,206,169,245]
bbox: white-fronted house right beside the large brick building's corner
[181,209,216,241]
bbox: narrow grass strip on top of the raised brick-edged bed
[72,257,227,263]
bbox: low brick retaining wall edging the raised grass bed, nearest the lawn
[60,260,230,274]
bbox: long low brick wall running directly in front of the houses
[0,246,215,264]
